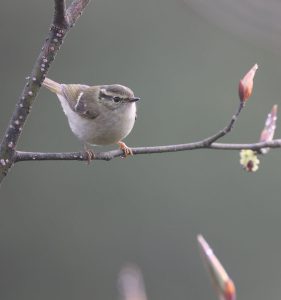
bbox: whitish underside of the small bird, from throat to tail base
[58,95,136,145]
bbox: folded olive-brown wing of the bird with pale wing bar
[62,84,101,119]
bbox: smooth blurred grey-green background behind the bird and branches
[0,0,281,300]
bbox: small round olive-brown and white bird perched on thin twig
[42,77,140,161]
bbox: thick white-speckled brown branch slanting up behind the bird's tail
[0,0,90,182]
